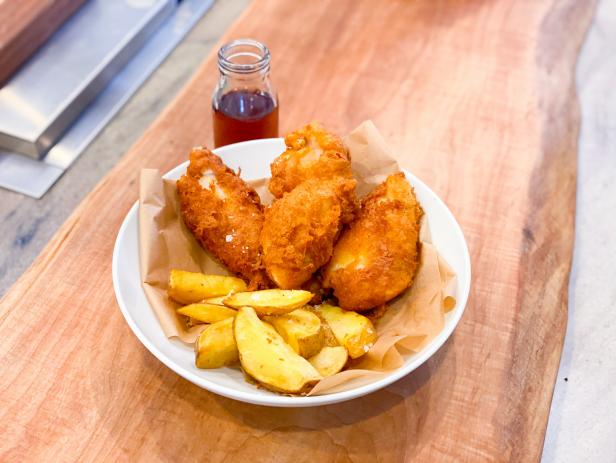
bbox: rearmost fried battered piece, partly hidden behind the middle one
[269,122,353,198]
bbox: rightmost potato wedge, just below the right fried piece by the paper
[315,304,376,359]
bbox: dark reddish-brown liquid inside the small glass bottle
[212,90,278,148]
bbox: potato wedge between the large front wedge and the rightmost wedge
[264,309,325,358]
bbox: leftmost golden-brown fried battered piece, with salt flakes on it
[177,147,270,289]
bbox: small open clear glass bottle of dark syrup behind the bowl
[212,39,278,147]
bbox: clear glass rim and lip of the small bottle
[218,39,271,74]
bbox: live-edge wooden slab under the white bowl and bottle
[0,0,594,462]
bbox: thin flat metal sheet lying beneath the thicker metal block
[0,0,213,198]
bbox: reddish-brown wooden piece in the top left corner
[0,0,85,86]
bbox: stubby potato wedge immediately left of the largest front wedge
[195,318,239,369]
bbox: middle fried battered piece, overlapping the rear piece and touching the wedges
[261,178,357,289]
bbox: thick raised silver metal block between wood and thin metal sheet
[0,0,174,159]
